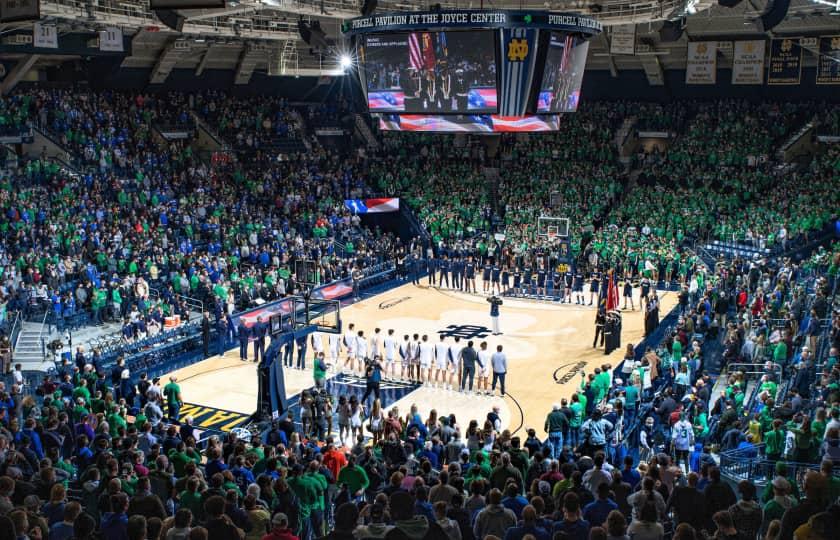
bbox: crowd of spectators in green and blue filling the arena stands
[0,87,840,540]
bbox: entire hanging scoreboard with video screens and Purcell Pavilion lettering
[342,9,601,133]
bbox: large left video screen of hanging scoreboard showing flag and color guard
[362,30,498,114]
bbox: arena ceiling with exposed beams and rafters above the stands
[3,0,840,84]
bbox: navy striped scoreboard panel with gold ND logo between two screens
[499,28,539,116]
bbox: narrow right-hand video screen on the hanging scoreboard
[537,33,589,113]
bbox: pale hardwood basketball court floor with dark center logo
[164,281,677,433]
